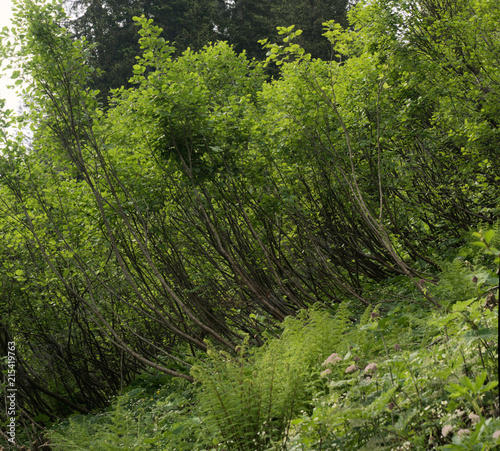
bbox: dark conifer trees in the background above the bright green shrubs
[64,0,348,100]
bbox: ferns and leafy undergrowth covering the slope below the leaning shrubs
[48,238,500,450]
